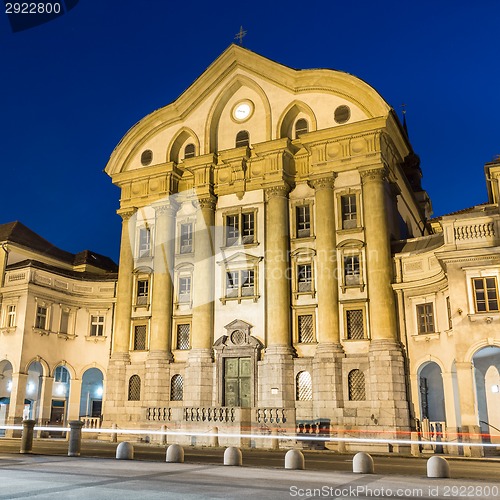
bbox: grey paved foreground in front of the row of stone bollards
[0,454,500,500]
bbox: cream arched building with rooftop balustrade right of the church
[393,159,500,453]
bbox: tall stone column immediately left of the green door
[184,196,216,406]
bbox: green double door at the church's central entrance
[224,358,252,408]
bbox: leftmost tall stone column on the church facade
[103,208,135,425]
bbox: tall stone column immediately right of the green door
[259,183,295,408]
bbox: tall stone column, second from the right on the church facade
[310,175,344,417]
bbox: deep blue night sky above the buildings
[0,0,500,260]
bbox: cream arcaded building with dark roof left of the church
[0,222,117,434]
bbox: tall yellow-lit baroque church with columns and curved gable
[103,45,432,449]
